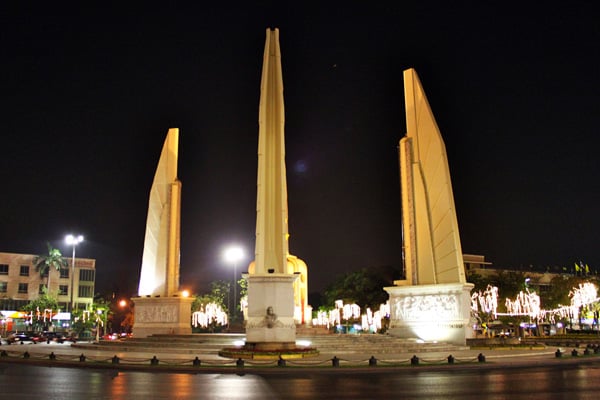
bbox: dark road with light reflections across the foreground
[0,364,600,400]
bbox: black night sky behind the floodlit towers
[0,1,600,293]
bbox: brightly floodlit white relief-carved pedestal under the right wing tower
[384,283,473,346]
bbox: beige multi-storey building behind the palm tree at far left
[0,253,96,311]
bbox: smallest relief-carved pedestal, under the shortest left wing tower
[132,297,194,338]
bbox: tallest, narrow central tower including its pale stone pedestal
[246,29,298,350]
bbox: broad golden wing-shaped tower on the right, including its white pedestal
[384,69,473,345]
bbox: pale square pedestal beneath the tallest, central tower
[246,273,297,350]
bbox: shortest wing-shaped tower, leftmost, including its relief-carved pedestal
[133,128,193,337]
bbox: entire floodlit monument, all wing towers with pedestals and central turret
[133,29,473,351]
